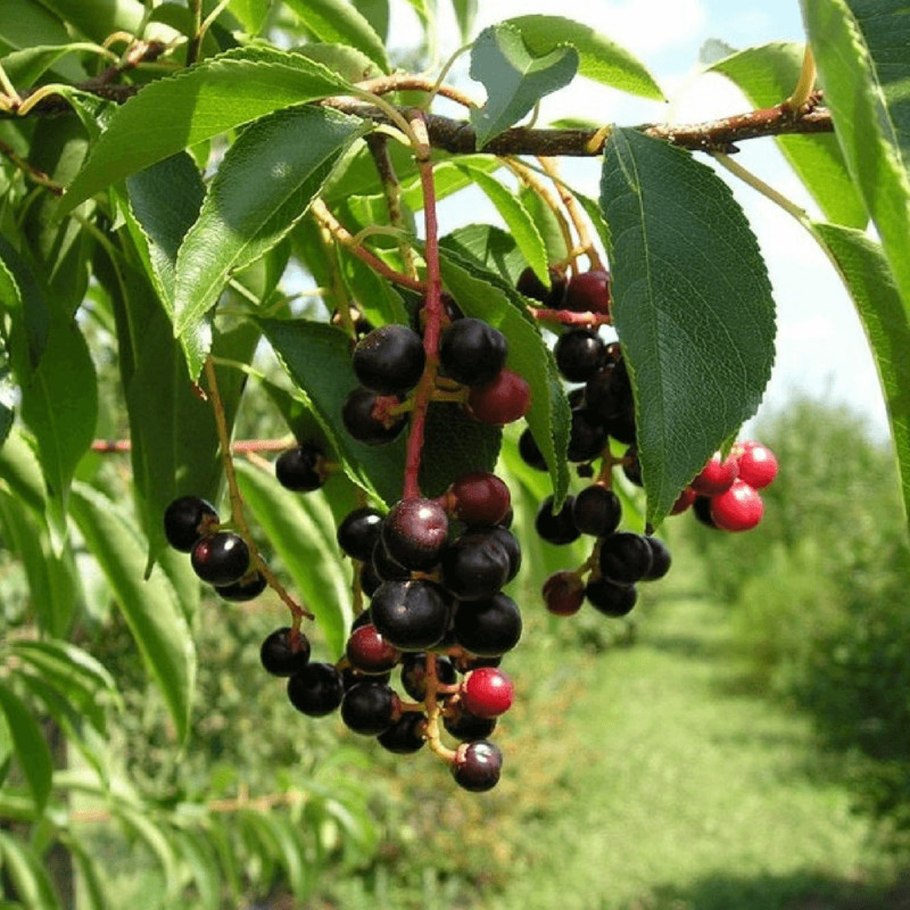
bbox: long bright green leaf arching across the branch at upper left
[60,47,349,214]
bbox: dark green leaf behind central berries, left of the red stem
[258,319,404,505]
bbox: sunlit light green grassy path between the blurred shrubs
[484,599,906,910]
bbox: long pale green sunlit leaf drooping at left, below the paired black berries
[70,484,196,741]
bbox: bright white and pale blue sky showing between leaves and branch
[391,0,887,435]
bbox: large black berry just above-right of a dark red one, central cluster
[370,580,452,651]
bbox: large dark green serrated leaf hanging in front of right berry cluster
[601,129,775,526]
